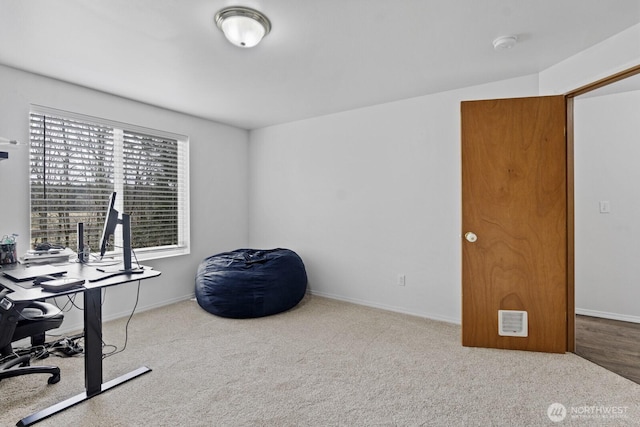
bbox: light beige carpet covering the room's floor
[0,296,640,426]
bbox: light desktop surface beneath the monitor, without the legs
[0,262,161,301]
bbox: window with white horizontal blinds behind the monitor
[29,106,189,259]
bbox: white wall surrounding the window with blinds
[0,66,249,329]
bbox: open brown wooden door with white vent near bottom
[461,96,567,352]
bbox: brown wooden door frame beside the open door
[565,65,640,353]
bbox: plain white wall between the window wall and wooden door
[249,76,538,323]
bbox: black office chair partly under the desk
[0,289,64,384]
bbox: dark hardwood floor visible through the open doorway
[576,315,640,384]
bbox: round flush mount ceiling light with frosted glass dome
[214,6,271,48]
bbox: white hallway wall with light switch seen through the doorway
[574,91,640,322]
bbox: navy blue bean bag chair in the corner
[196,249,307,319]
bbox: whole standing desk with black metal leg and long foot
[0,263,161,427]
